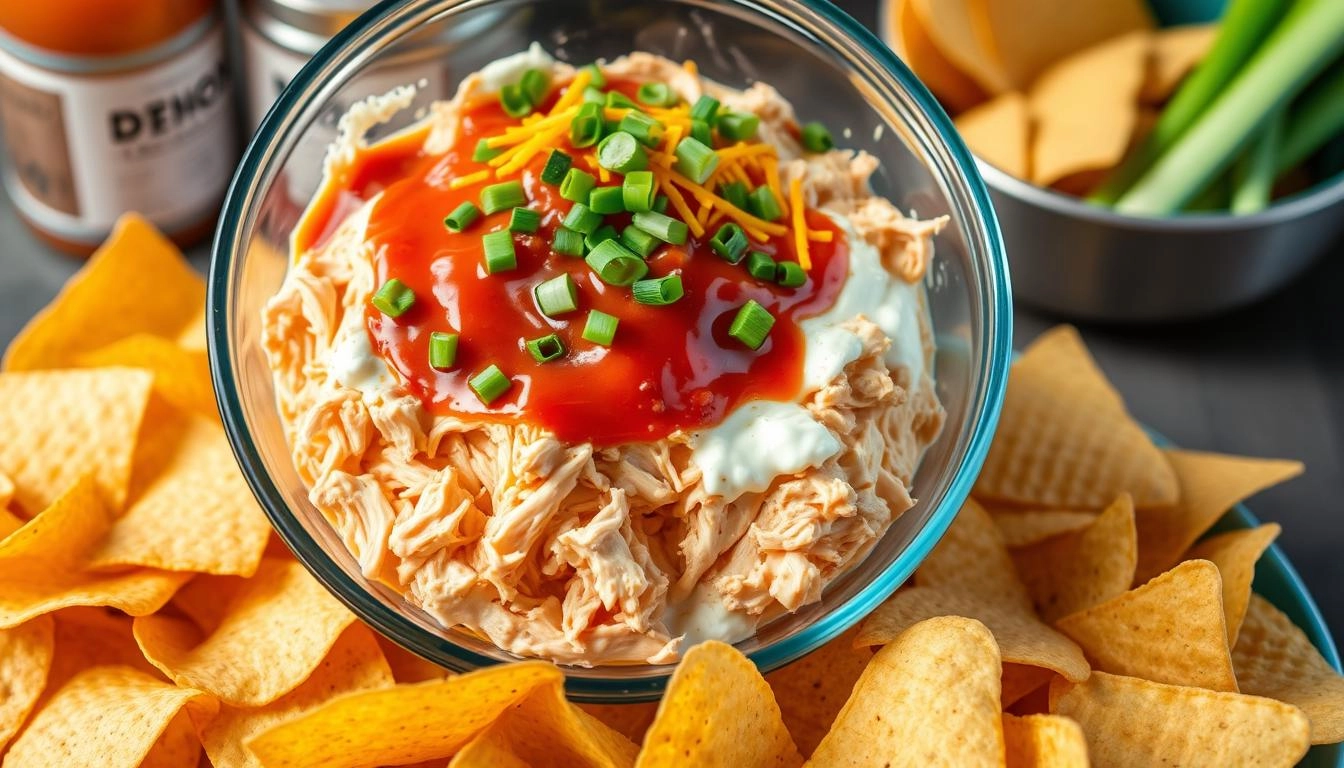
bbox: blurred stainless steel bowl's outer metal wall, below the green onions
[977,161,1344,323]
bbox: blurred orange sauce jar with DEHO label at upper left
[0,0,238,254]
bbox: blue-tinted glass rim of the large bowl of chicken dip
[207,0,1012,702]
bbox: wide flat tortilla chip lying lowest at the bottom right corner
[1051,673,1310,768]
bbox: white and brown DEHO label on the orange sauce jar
[0,24,237,242]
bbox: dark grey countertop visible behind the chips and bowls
[0,0,1344,638]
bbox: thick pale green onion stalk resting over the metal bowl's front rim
[1116,0,1344,215]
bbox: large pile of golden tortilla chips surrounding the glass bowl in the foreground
[0,218,1344,768]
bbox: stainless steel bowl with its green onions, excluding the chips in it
[980,0,1344,323]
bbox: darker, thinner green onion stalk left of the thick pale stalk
[1087,0,1292,206]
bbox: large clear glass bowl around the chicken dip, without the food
[210,0,1012,702]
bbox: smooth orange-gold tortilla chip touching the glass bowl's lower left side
[91,406,270,576]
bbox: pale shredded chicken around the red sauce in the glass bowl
[262,54,943,666]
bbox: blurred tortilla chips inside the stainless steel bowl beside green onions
[884,0,1216,195]
